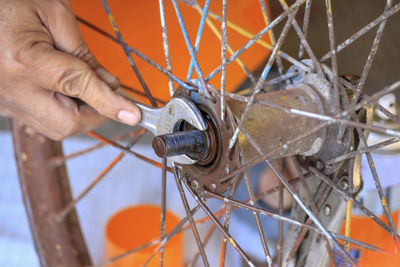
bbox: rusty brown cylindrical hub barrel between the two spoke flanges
[227,84,325,163]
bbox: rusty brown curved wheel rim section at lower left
[12,120,91,267]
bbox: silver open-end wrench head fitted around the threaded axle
[137,97,207,164]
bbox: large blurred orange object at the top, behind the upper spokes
[71,0,270,103]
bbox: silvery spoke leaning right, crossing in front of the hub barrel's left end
[229,8,298,150]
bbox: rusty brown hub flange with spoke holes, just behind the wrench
[175,85,239,193]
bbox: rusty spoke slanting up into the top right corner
[320,3,400,62]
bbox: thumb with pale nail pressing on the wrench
[29,42,141,125]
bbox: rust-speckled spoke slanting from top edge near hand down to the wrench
[101,0,157,107]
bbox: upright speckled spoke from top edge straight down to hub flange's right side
[220,0,228,121]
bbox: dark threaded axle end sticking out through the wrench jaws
[152,129,208,160]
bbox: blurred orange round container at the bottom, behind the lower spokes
[105,205,184,267]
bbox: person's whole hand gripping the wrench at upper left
[0,0,141,140]
